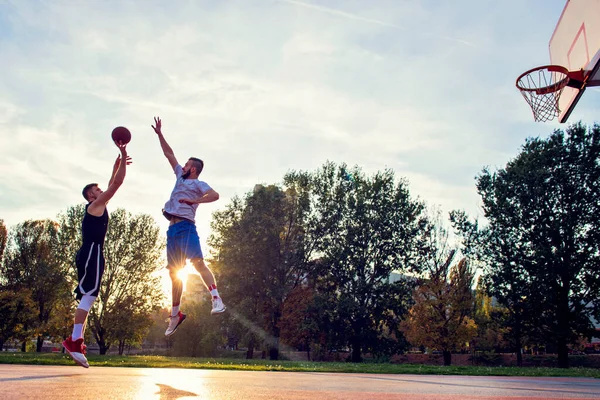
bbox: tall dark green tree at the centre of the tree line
[284,163,425,362]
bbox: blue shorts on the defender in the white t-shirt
[167,220,204,268]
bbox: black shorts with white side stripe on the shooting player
[75,243,104,300]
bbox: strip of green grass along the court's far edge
[0,352,600,378]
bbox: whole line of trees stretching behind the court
[0,123,600,367]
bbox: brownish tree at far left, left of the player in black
[1,220,68,352]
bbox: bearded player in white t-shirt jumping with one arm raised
[152,117,225,336]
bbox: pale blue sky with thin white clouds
[0,0,600,258]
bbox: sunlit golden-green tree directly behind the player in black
[59,206,164,354]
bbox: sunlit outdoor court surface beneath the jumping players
[0,364,600,400]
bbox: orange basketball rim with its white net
[517,65,570,122]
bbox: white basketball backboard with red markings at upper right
[549,0,600,123]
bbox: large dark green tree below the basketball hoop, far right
[460,123,600,368]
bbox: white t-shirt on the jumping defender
[165,165,211,222]
